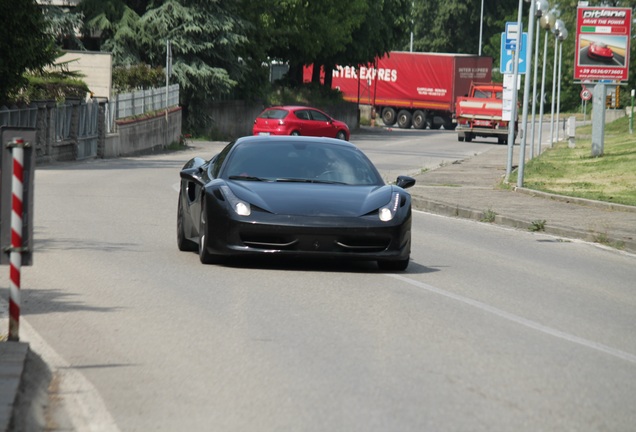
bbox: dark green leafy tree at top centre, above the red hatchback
[243,0,411,85]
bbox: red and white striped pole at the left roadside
[9,138,24,341]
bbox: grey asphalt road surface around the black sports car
[0,127,636,431]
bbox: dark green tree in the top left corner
[0,0,57,101]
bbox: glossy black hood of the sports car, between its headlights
[228,181,393,217]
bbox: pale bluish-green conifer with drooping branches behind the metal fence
[137,0,247,129]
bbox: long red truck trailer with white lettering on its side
[304,51,492,129]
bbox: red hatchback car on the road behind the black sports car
[252,106,349,141]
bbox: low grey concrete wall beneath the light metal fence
[103,108,183,158]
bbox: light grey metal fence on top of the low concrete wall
[106,84,179,133]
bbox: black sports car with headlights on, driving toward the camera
[177,136,415,270]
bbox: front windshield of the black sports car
[221,139,384,185]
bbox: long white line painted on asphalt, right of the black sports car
[386,273,636,363]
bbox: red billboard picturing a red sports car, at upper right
[574,7,632,81]
